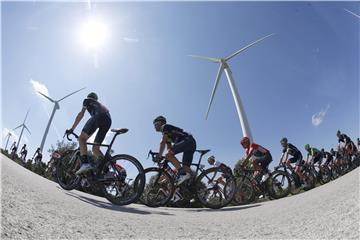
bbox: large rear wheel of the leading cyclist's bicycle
[101,154,145,206]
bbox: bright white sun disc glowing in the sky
[78,18,109,50]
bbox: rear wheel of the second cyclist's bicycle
[195,167,236,209]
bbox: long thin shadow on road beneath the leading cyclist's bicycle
[65,192,174,216]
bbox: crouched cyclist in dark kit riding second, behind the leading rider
[153,116,196,185]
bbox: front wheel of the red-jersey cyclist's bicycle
[233,175,255,205]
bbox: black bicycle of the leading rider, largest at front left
[56,128,145,205]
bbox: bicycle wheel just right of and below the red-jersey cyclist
[269,170,291,199]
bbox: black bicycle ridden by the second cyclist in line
[140,150,235,209]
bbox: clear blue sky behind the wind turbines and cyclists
[1,2,360,169]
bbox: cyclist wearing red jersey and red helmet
[240,137,272,182]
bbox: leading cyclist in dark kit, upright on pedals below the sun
[65,92,111,174]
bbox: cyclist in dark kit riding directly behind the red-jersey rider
[280,137,305,182]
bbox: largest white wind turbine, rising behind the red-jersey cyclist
[190,33,274,142]
